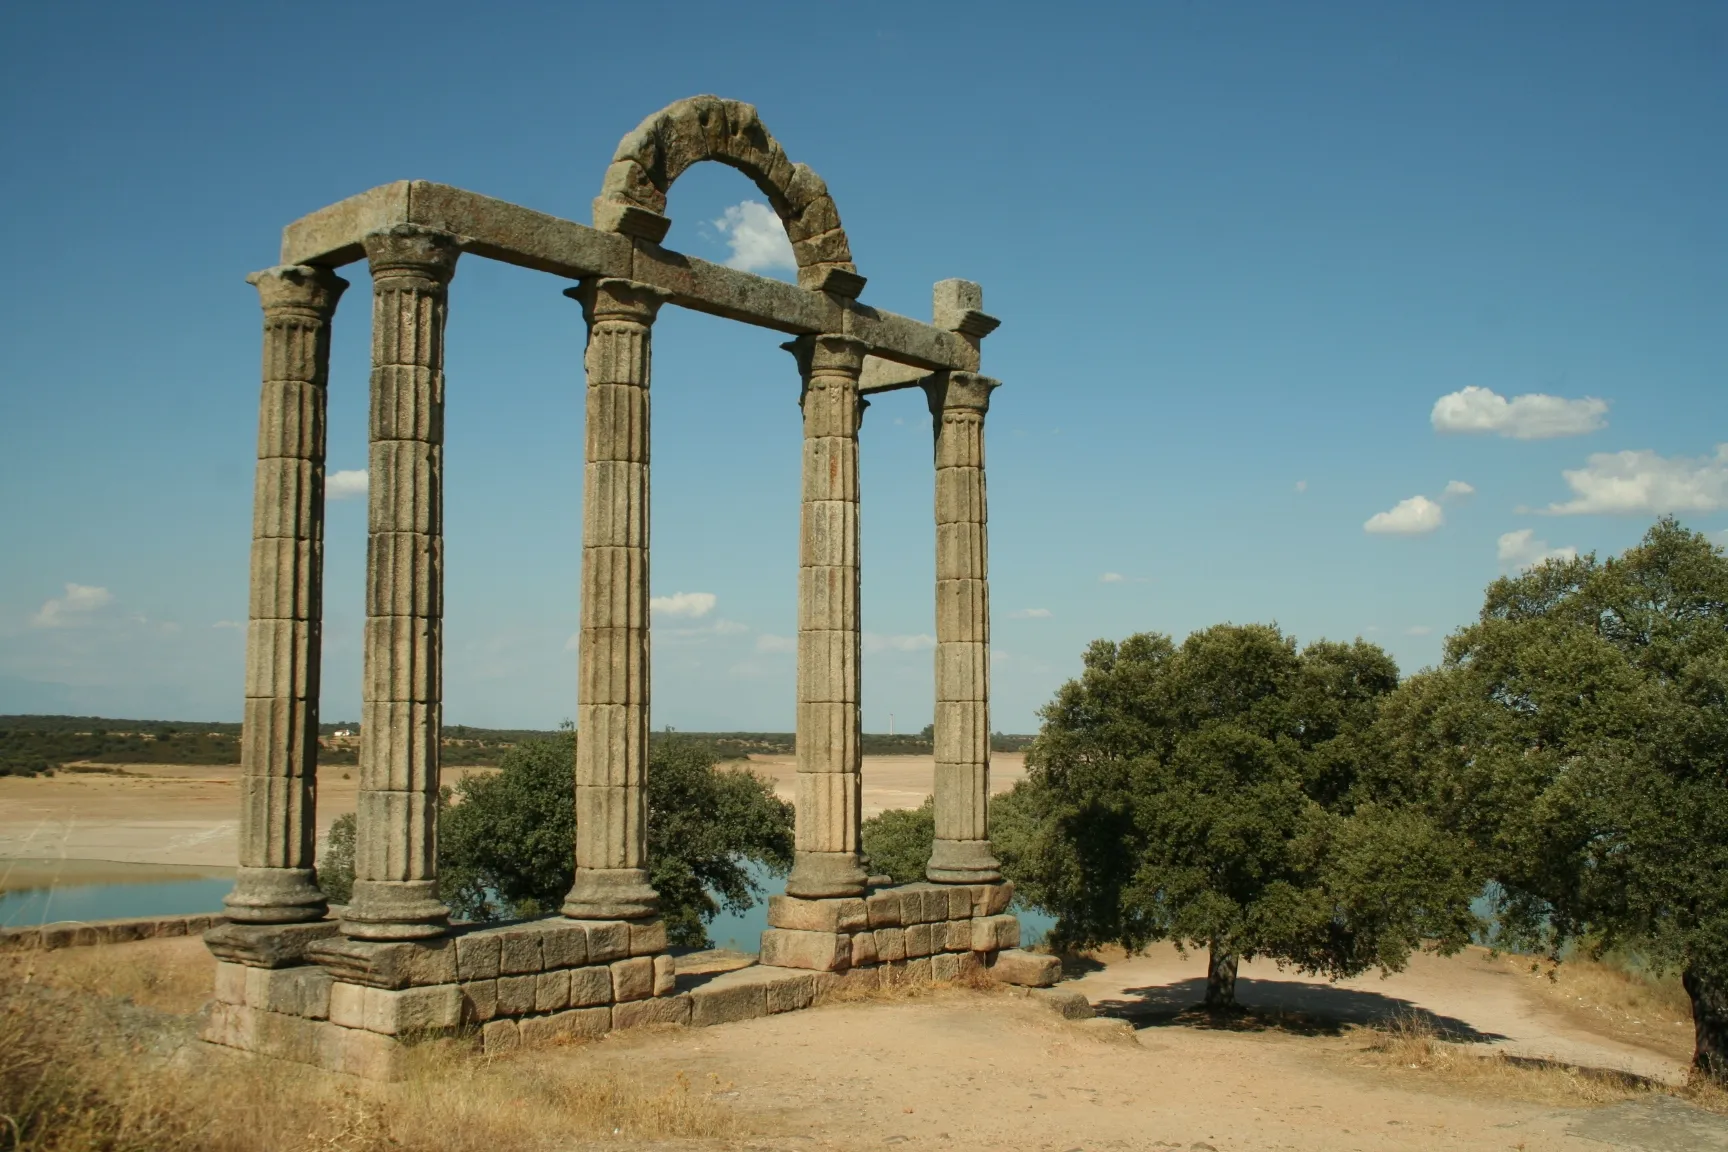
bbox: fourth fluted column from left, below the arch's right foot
[786,335,866,898]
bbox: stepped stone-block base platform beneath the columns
[202,884,1059,1079]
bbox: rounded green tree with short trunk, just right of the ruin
[995,625,1479,1005]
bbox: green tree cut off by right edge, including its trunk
[1384,520,1728,1081]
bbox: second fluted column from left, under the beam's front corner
[342,225,460,940]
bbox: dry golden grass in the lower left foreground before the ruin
[0,941,741,1152]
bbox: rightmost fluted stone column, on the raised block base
[926,371,1002,884]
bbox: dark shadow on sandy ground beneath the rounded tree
[1094,978,1505,1043]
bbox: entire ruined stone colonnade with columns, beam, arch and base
[206,97,1051,1076]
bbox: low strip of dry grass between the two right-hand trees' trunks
[1353,1012,1668,1107]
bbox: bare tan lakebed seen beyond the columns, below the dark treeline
[0,753,1025,873]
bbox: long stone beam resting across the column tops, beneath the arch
[282,180,978,371]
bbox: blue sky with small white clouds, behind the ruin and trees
[0,2,1728,731]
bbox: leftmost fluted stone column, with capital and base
[225,264,347,924]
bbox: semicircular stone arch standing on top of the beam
[594,97,864,297]
